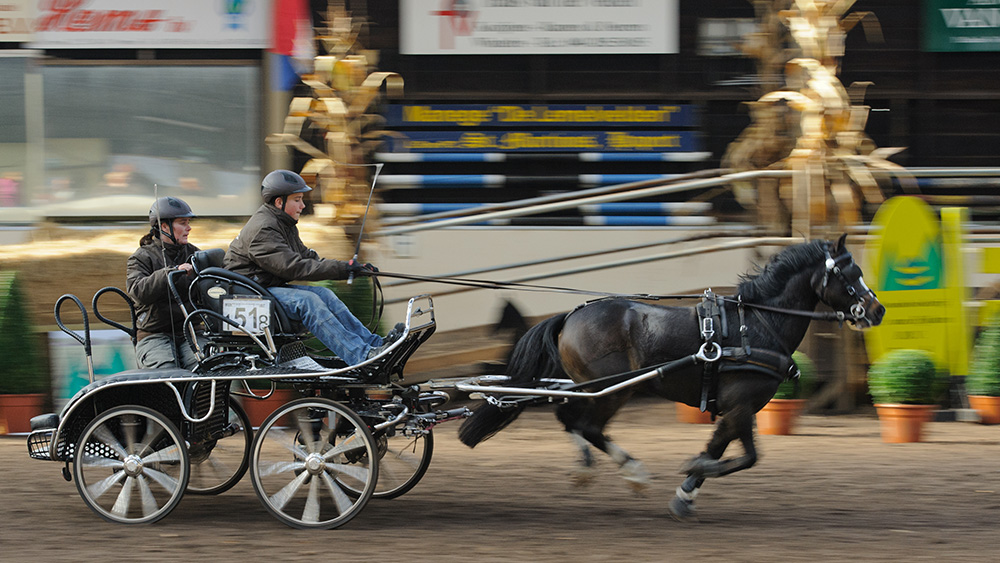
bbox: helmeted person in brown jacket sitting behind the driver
[125,197,208,370]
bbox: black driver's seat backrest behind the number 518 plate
[190,266,298,342]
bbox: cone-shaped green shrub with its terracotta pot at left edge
[0,271,49,434]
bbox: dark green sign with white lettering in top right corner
[923,0,1000,52]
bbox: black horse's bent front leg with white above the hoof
[668,413,757,522]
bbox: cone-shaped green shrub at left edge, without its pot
[0,271,49,395]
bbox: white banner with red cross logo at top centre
[399,0,680,55]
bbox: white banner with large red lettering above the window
[28,0,270,49]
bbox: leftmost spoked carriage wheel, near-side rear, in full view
[73,406,190,524]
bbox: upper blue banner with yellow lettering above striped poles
[385,104,696,127]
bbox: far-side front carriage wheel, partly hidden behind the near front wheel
[344,428,434,499]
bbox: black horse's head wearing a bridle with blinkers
[813,233,885,328]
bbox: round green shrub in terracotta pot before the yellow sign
[868,350,943,443]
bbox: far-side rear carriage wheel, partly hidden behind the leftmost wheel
[187,401,253,495]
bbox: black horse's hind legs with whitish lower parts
[556,401,650,491]
